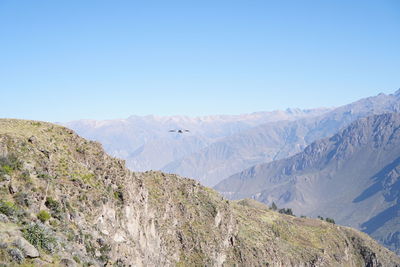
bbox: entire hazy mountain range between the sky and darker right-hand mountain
[64,90,400,186]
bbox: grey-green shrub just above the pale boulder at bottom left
[23,224,57,253]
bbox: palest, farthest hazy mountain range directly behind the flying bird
[64,108,330,173]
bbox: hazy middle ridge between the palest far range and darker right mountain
[166,90,400,186]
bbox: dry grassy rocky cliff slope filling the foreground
[0,119,400,266]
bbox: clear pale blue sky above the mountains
[0,0,400,121]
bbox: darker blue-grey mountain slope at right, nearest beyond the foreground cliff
[215,112,400,253]
